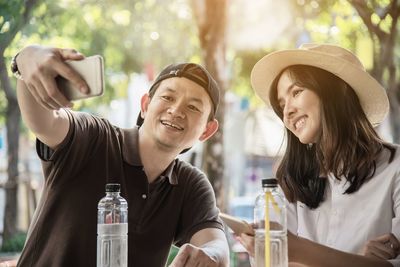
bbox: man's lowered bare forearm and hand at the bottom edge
[170,228,229,267]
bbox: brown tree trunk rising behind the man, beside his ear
[192,0,228,210]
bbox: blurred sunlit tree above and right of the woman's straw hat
[295,0,400,143]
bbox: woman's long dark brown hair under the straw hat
[269,65,395,208]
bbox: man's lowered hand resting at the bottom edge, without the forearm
[170,244,219,267]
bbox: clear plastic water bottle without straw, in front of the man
[97,184,128,267]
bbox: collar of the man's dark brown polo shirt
[121,126,178,185]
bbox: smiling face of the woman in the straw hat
[277,71,321,144]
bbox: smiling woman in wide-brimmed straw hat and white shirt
[240,44,400,267]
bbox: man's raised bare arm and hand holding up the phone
[16,46,87,148]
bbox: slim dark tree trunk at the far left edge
[0,57,21,245]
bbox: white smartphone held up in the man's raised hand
[56,55,104,101]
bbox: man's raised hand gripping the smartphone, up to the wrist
[16,45,89,110]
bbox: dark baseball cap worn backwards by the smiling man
[136,63,219,126]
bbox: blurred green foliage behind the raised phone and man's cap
[0,0,199,114]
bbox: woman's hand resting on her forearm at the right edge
[362,233,400,260]
